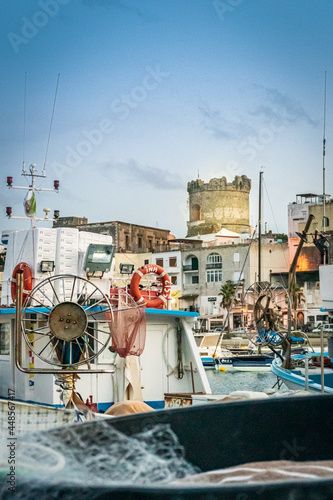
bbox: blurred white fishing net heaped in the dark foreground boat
[0,422,200,500]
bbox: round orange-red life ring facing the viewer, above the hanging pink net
[130,264,171,308]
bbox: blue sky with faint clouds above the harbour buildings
[0,0,333,237]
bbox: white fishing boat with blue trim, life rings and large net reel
[0,165,211,411]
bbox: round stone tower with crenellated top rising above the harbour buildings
[187,175,251,237]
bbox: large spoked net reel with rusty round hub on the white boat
[22,275,113,368]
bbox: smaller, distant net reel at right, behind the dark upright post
[244,281,290,346]
